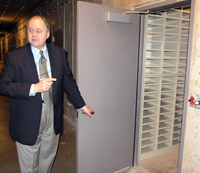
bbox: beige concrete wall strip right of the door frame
[181,0,200,173]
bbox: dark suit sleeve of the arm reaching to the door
[63,51,85,109]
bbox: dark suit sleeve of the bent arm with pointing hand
[0,53,31,99]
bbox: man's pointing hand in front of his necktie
[34,78,56,93]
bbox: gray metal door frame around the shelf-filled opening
[132,0,196,173]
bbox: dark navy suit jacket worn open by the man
[0,44,85,145]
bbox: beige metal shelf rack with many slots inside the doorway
[138,6,190,160]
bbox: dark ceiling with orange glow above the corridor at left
[0,0,45,37]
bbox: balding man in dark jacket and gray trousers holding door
[0,16,94,173]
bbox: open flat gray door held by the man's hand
[76,1,139,173]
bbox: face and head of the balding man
[28,18,50,50]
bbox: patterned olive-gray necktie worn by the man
[39,50,53,106]
